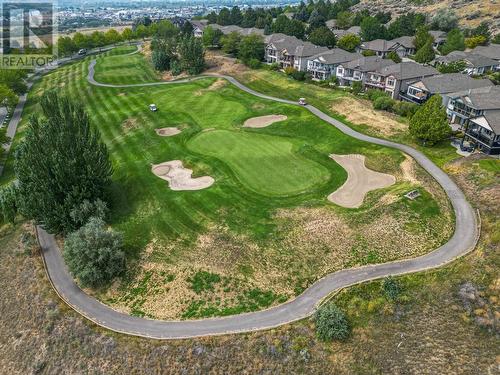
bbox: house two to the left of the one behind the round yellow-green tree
[336,56,394,86]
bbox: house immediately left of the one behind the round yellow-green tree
[365,62,439,99]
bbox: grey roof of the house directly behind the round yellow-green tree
[412,73,493,94]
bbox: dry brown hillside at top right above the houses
[352,0,500,34]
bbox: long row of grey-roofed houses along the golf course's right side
[189,20,500,155]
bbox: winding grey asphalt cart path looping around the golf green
[33,60,479,339]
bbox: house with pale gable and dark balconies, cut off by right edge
[462,109,500,155]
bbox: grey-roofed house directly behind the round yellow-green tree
[400,73,493,106]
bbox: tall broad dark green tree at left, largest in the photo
[15,91,112,233]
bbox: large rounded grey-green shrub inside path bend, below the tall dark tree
[63,218,125,288]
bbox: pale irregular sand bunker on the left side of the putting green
[151,160,215,191]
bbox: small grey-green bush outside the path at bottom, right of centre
[313,303,351,341]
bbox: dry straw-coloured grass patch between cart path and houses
[331,97,407,136]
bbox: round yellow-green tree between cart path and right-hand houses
[409,95,450,145]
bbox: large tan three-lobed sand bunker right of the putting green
[328,154,396,208]
